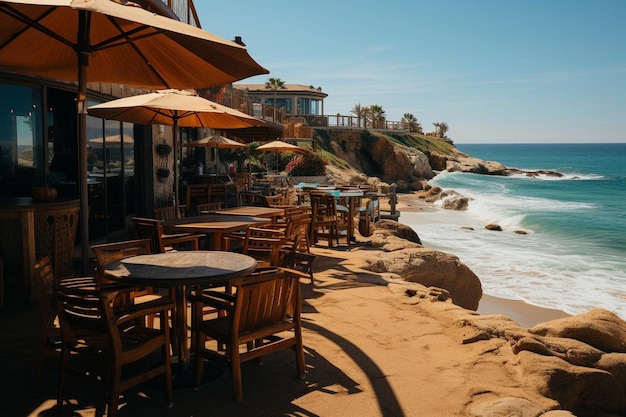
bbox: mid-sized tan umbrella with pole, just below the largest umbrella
[89,89,264,204]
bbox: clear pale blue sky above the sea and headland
[194,0,626,143]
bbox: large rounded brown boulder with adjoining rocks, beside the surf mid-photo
[361,220,482,310]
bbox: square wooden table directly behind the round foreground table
[161,214,272,250]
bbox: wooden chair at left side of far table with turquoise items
[310,192,349,247]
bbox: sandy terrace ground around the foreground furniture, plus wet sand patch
[0,207,580,417]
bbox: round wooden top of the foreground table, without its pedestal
[103,251,257,287]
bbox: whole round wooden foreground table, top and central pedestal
[103,251,257,364]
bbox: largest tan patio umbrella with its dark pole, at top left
[0,0,269,273]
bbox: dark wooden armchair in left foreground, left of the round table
[56,285,174,417]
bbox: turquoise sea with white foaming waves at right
[400,144,626,319]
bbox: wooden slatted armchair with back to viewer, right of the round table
[190,268,305,401]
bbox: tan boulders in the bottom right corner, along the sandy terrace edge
[400,284,626,417]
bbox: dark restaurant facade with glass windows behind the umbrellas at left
[0,0,282,307]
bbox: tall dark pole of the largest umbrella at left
[77,11,90,275]
